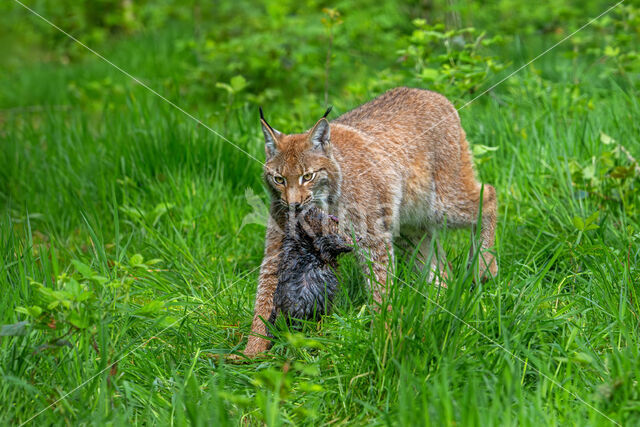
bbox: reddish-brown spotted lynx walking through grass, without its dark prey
[244,87,498,357]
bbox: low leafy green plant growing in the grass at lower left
[2,254,175,351]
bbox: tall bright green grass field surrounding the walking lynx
[0,2,640,425]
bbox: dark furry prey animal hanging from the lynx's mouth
[269,207,353,338]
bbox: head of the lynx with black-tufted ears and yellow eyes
[260,108,340,210]
